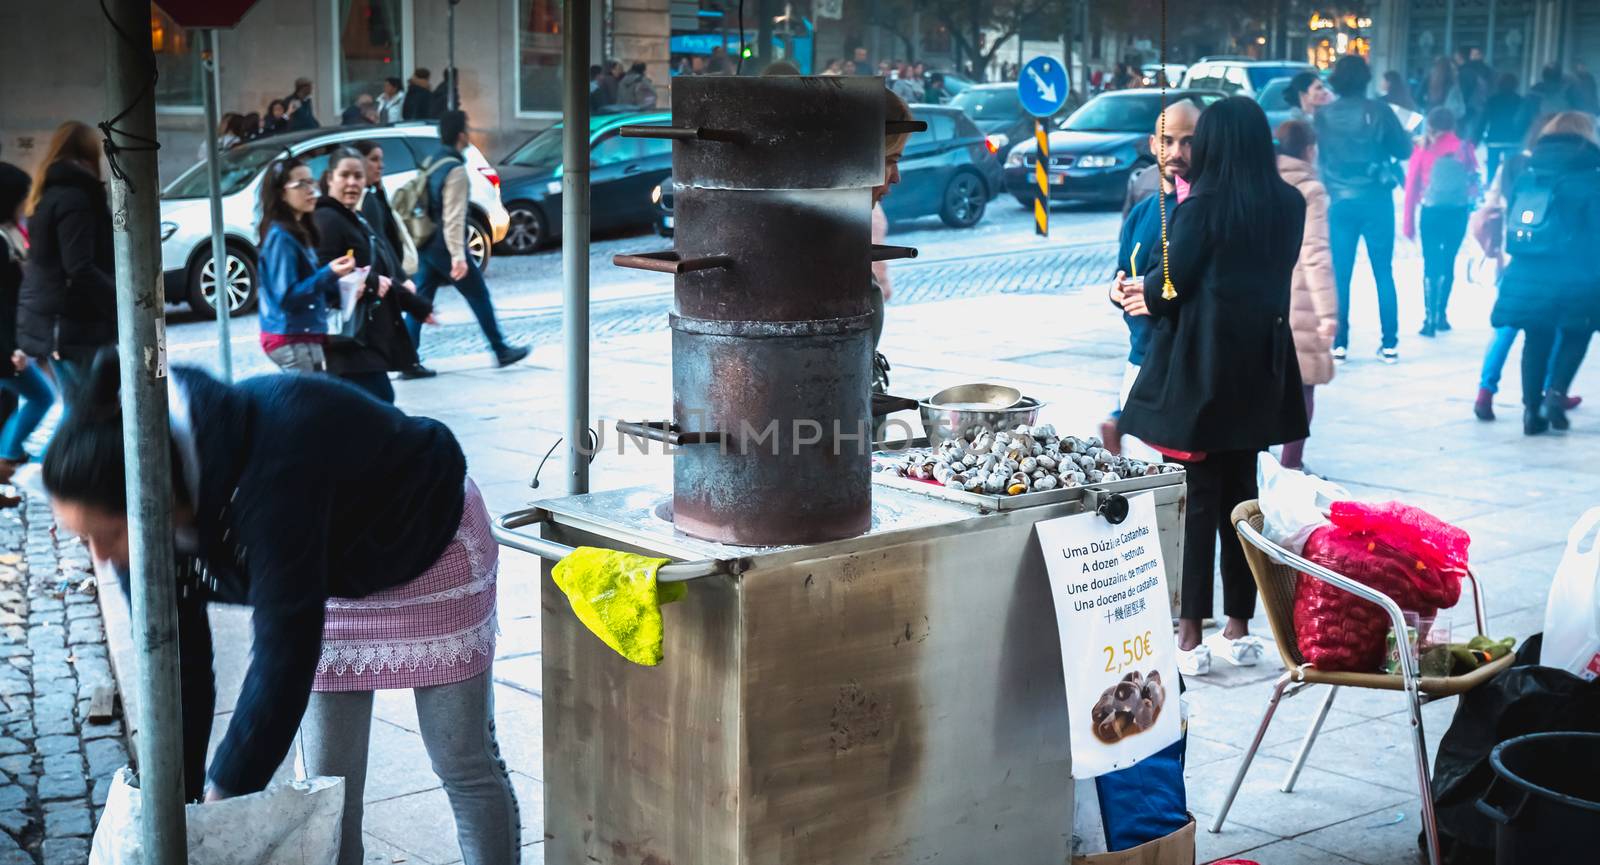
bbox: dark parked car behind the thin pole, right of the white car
[499,112,672,254]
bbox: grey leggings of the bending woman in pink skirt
[301,670,522,865]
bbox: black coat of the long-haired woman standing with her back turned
[1118,186,1305,452]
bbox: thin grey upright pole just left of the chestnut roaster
[562,2,590,496]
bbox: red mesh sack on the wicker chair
[1294,502,1470,673]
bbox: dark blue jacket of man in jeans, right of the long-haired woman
[1312,96,1411,201]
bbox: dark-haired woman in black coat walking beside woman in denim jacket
[312,149,434,403]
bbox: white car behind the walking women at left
[162,123,510,315]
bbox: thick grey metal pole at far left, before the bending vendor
[107,0,189,865]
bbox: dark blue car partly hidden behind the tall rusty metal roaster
[650,104,1005,237]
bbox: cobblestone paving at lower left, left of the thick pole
[0,500,128,865]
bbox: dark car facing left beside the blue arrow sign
[1005,90,1224,208]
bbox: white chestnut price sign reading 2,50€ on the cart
[1035,496,1182,779]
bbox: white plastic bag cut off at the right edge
[1539,507,1600,681]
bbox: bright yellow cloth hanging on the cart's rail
[550,547,686,667]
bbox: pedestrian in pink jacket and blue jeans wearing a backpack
[1402,107,1483,336]
